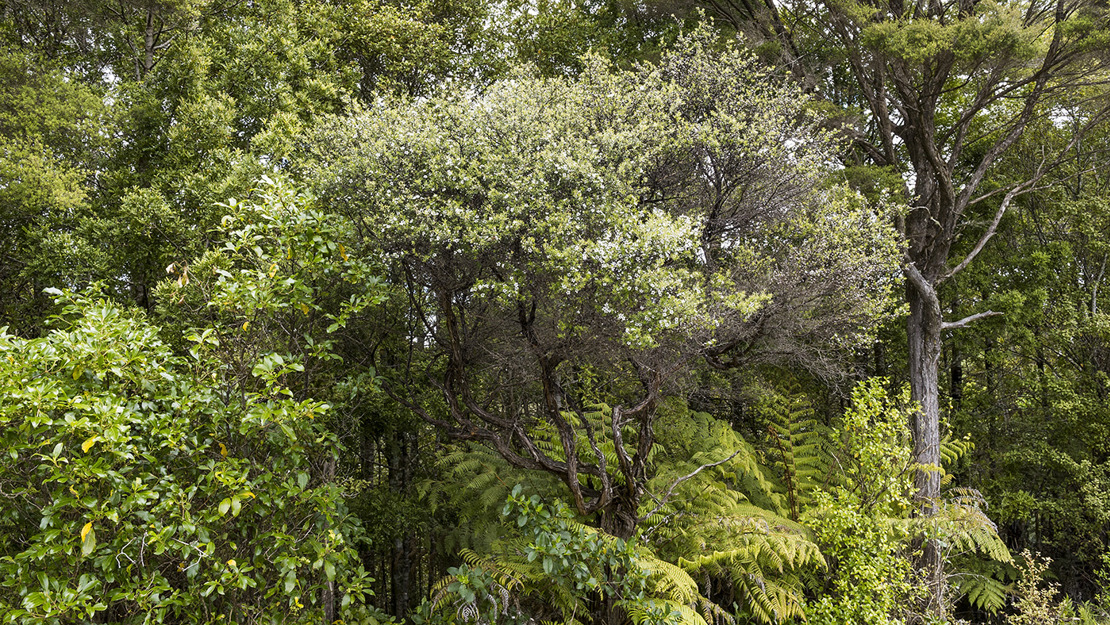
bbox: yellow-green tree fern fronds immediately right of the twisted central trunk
[645,404,825,623]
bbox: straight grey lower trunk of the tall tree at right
[906,283,945,618]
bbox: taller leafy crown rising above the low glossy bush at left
[157,177,383,390]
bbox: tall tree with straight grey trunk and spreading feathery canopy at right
[670,0,1108,613]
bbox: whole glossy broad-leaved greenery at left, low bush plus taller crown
[0,180,390,623]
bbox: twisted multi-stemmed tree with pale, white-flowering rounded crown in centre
[312,34,897,546]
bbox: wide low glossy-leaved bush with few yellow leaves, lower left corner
[0,294,381,623]
